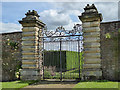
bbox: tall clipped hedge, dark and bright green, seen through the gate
[44,51,82,71]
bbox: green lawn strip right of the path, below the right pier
[73,81,120,90]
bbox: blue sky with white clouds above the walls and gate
[0,0,118,33]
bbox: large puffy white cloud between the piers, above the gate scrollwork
[40,9,79,30]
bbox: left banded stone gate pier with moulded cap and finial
[19,10,45,80]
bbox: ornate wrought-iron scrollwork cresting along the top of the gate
[42,25,83,41]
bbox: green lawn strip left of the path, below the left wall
[2,80,37,90]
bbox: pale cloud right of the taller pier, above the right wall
[95,2,118,22]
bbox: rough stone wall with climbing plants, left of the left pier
[2,32,22,81]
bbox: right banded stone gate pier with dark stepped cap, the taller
[79,4,102,79]
